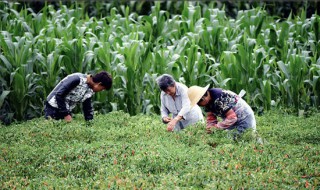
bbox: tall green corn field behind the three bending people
[0,1,320,123]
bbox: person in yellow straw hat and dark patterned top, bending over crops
[188,85,256,138]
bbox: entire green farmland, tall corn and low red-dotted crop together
[0,1,320,189]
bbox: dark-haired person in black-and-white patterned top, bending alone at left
[44,71,112,122]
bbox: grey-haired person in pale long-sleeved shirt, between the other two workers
[157,74,203,131]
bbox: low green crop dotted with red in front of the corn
[0,110,320,189]
